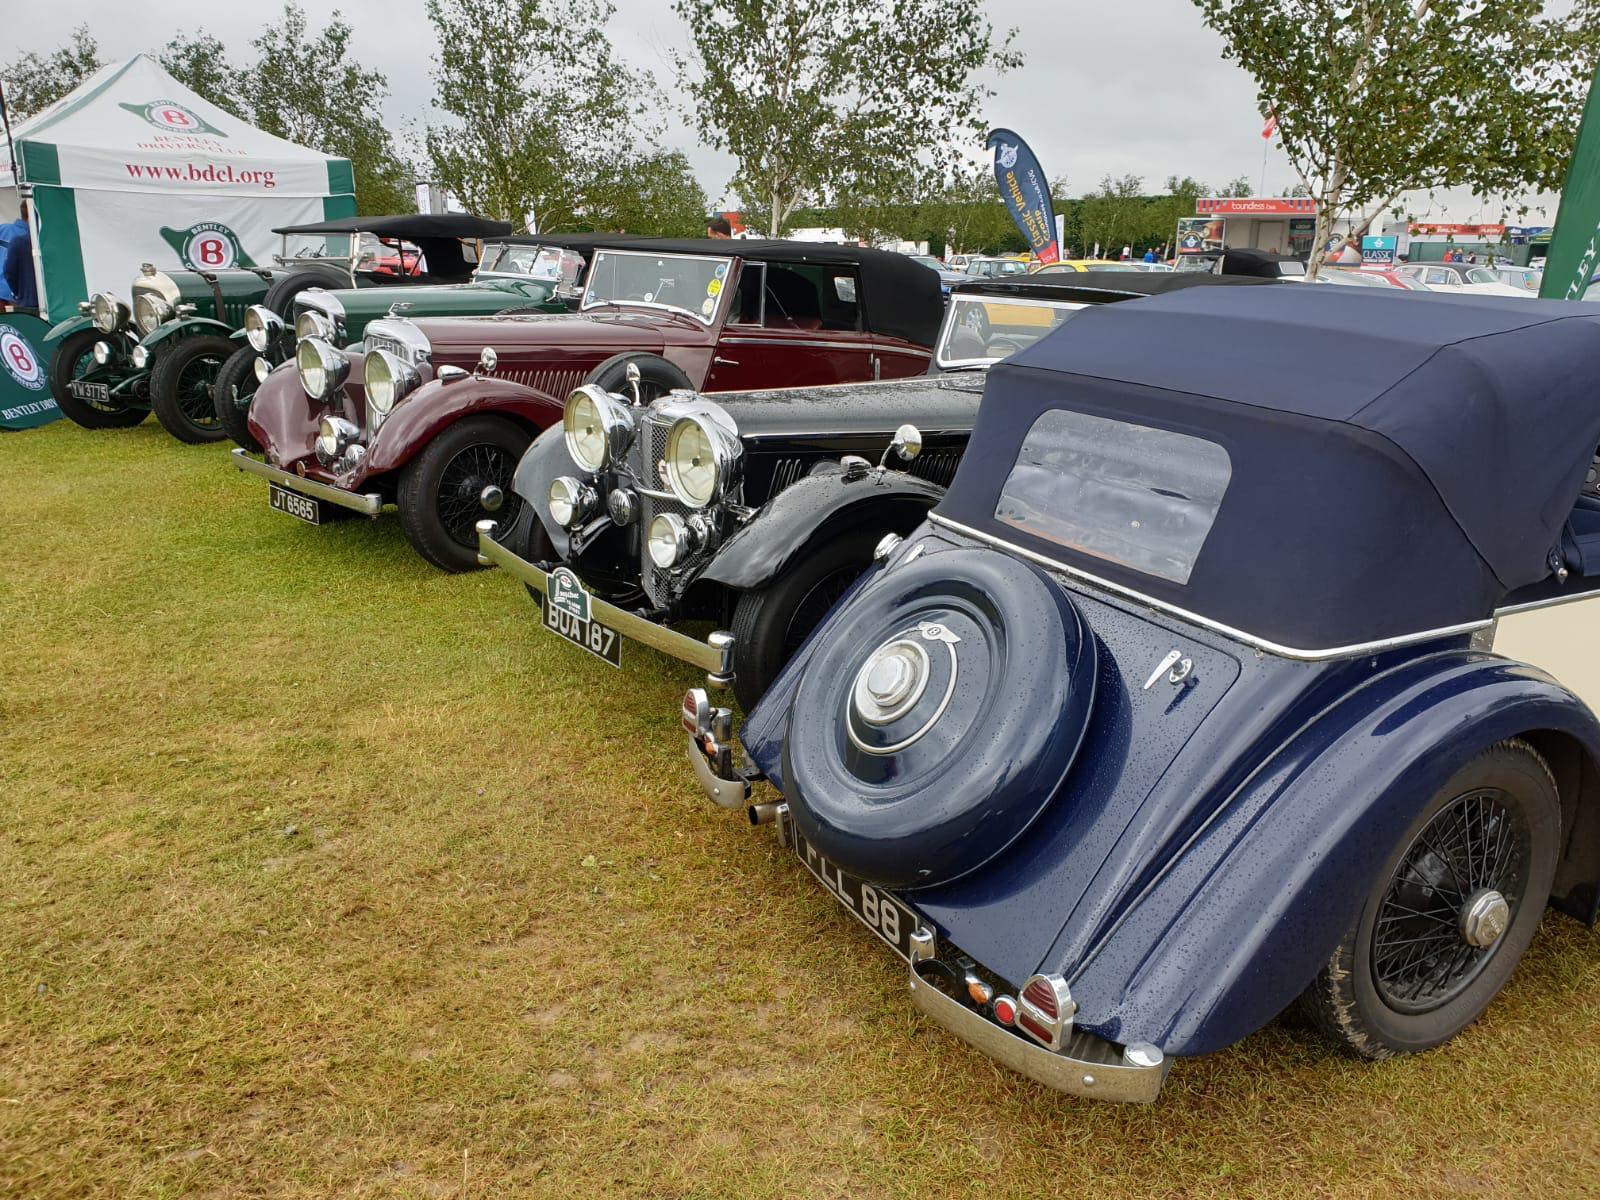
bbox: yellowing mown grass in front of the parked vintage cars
[9,422,1600,1200]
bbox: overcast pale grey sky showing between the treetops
[3,0,1555,224]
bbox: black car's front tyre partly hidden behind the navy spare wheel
[730,526,883,712]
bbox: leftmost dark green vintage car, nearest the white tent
[46,213,512,442]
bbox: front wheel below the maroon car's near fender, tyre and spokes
[397,416,533,571]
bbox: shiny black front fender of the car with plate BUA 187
[699,464,944,592]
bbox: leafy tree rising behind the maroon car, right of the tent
[426,0,656,232]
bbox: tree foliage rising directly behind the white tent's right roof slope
[160,3,416,213]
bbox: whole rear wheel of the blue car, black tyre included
[1299,741,1562,1059]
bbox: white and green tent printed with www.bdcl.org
[0,54,355,320]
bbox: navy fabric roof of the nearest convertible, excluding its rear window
[939,285,1600,650]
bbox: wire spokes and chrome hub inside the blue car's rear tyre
[1371,789,1531,1013]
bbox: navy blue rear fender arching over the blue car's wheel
[1062,650,1600,1054]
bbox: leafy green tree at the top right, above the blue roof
[1195,0,1600,272]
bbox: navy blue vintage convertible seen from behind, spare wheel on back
[683,288,1600,1101]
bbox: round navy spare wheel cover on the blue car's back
[784,549,1094,888]
